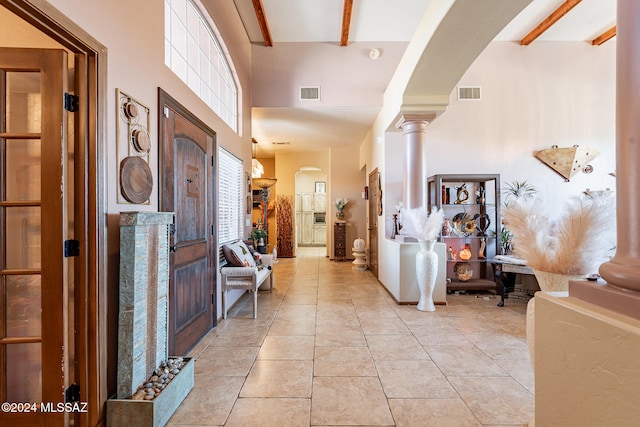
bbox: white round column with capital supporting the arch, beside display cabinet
[396,114,436,209]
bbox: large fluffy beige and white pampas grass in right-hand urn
[503,194,616,275]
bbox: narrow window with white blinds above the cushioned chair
[218,147,245,245]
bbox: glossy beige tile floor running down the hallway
[168,248,534,427]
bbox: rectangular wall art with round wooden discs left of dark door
[116,89,153,204]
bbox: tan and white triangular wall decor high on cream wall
[535,145,600,181]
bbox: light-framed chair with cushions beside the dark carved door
[220,240,273,319]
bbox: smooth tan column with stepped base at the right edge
[569,0,640,318]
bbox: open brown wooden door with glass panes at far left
[0,48,74,426]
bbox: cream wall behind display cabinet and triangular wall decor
[427,40,616,215]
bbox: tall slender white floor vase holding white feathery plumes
[402,207,444,311]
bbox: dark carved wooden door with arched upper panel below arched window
[159,91,217,355]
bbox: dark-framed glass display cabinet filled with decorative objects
[427,174,501,291]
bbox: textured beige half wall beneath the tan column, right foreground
[535,293,640,427]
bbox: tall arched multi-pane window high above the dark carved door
[164,0,238,132]
